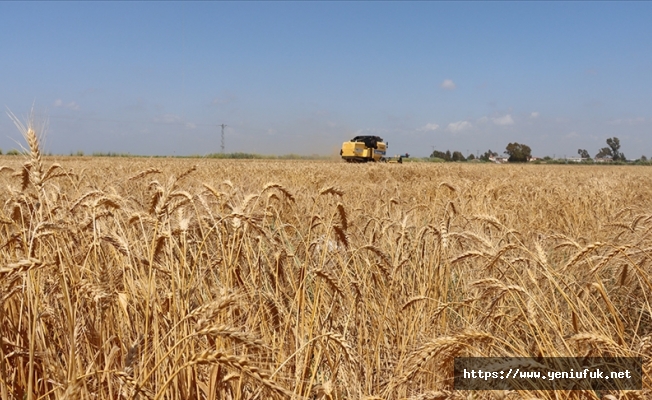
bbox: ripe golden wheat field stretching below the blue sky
[0,127,652,400]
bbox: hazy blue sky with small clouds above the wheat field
[0,1,652,158]
